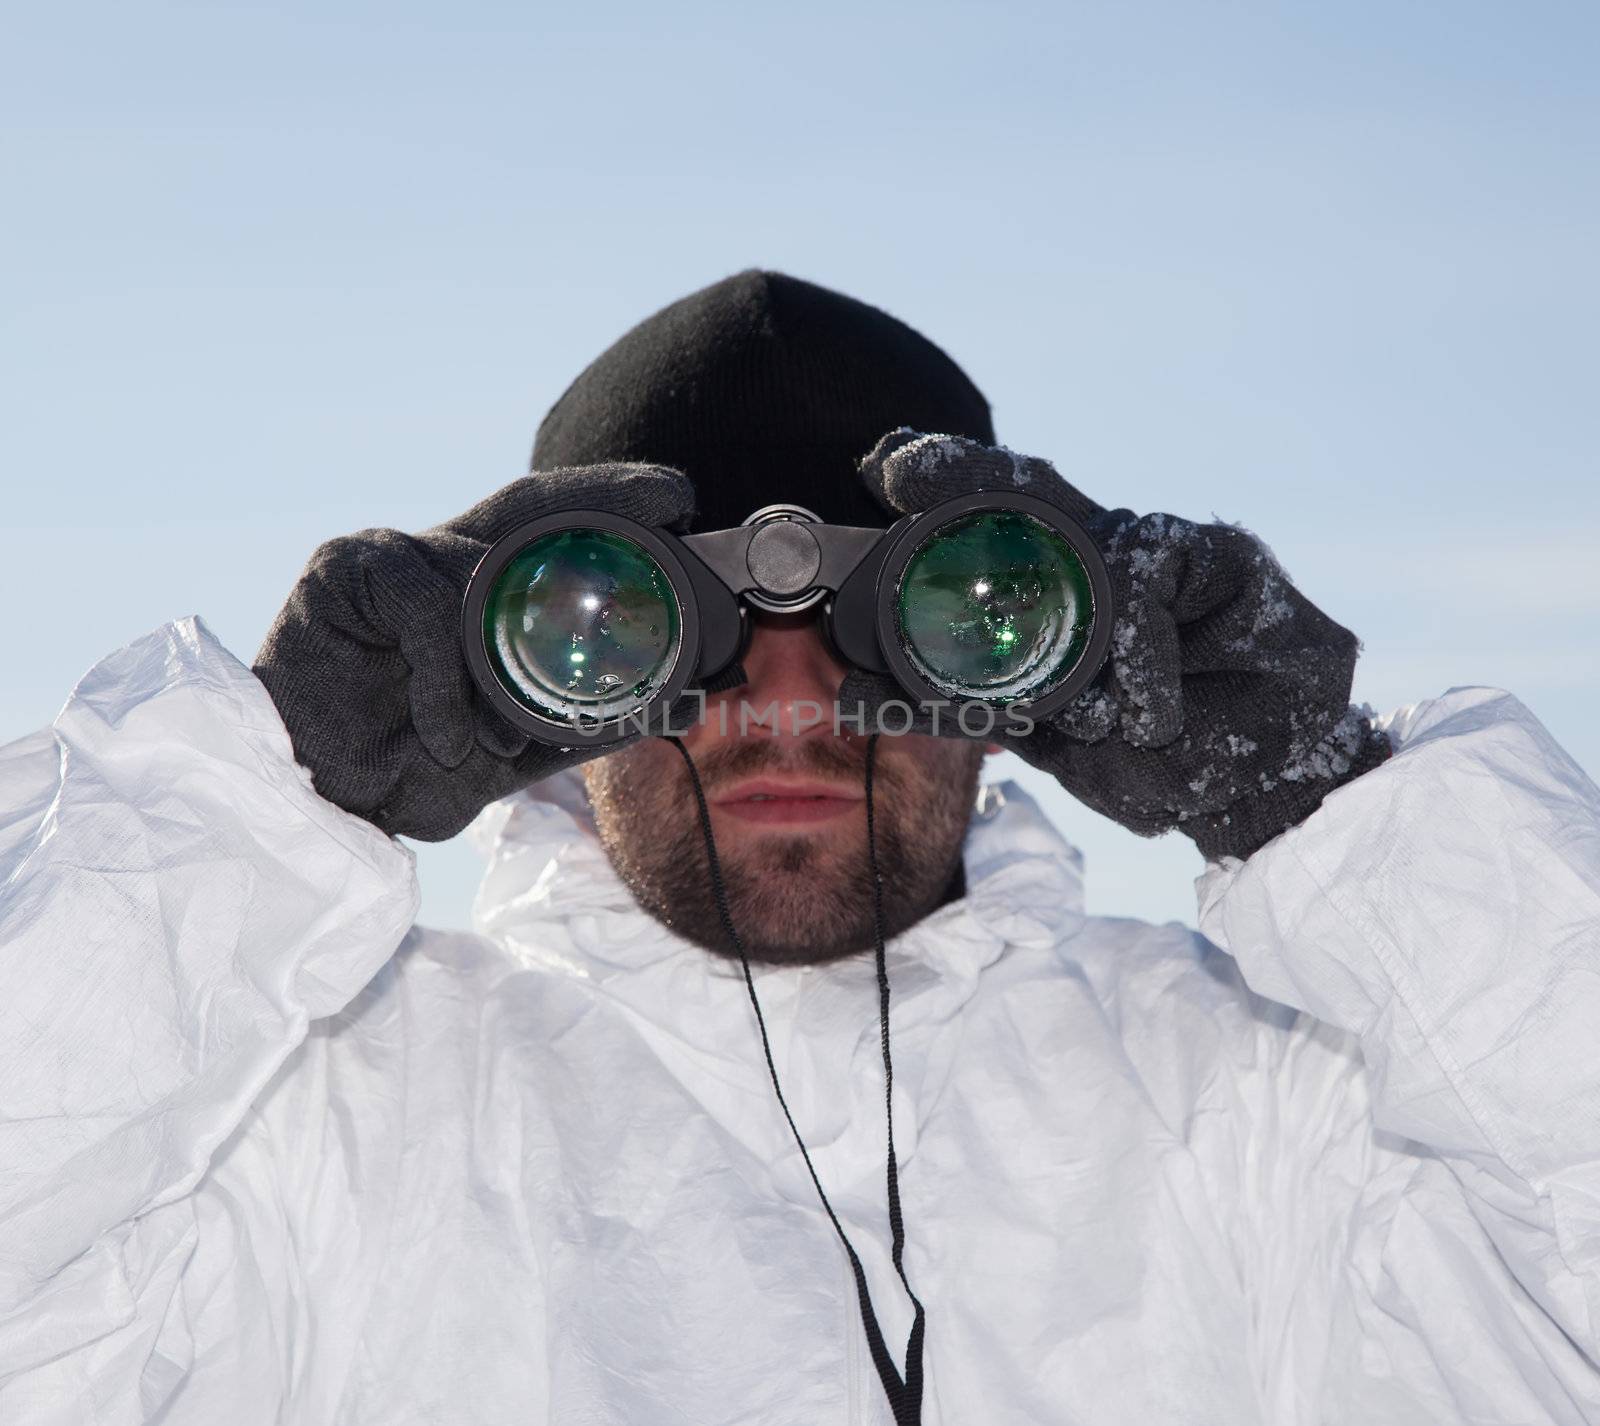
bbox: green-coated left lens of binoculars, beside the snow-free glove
[483,530,682,722]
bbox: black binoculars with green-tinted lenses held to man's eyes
[462,491,1114,746]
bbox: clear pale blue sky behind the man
[0,0,1600,925]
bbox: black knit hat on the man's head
[533,269,994,530]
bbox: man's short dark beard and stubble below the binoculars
[586,738,982,965]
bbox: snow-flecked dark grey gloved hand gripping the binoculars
[840,429,1390,859]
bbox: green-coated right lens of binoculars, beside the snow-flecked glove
[894,511,1094,704]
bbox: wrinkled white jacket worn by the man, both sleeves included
[0,621,1600,1426]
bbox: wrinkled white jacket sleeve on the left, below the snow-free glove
[0,619,416,1423]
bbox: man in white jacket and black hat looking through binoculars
[0,272,1600,1426]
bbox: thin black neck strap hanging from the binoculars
[666,733,926,1426]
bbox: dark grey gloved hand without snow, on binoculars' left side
[254,464,694,842]
